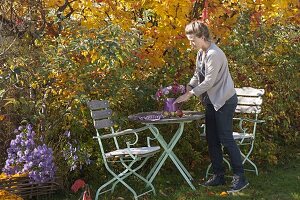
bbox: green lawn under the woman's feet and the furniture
[53,155,300,200]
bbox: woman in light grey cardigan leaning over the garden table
[174,21,249,192]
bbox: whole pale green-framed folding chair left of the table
[87,100,160,200]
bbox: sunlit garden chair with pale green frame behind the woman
[200,87,265,178]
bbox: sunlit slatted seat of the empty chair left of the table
[105,146,160,158]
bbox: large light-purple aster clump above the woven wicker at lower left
[2,124,55,182]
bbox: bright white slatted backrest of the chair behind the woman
[235,87,265,114]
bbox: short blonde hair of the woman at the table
[185,21,210,41]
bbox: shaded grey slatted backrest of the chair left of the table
[87,100,114,129]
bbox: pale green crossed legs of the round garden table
[147,122,195,190]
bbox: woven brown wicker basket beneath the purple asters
[0,177,59,199]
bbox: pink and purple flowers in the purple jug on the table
[154,83,186,101]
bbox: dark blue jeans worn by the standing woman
[205,94,244,175]
